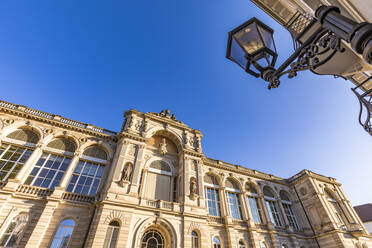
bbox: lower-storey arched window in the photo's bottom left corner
[0,213,28,247]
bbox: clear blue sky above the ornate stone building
[0,0,372,204]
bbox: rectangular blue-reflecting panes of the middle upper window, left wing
[25,152,71,189]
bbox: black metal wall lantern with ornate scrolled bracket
[226,6,372,135]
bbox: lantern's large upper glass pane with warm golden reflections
[233,23,264,54]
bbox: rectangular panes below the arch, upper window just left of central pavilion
[66,160,105,196]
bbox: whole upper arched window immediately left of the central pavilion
[66,146,107,196]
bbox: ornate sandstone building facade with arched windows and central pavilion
[0,101,372,248]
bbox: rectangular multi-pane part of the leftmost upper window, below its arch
[0,144,33,181]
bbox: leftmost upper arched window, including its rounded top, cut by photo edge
[0,129,39,181]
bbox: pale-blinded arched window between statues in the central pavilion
[145,160,174,201]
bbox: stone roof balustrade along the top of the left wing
[0,100,116,136]
